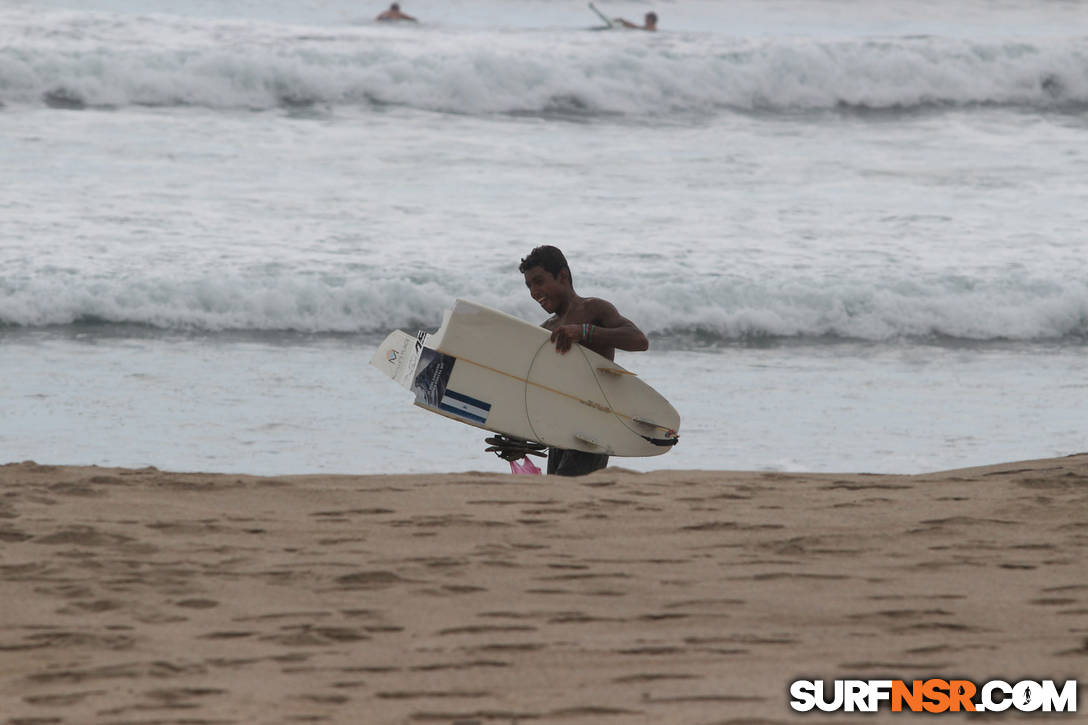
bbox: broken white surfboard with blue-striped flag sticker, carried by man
[371,299,680,456]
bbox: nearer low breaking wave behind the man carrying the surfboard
[0,269,1088,347]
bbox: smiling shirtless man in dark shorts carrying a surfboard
[518,246,650,476]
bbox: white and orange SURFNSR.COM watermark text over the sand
[790,678,1077,713]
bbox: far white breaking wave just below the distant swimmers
[0,13,1088,118]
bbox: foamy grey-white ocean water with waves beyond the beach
[0,0,1088,475]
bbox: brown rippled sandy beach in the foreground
[0,454,1088,725]
